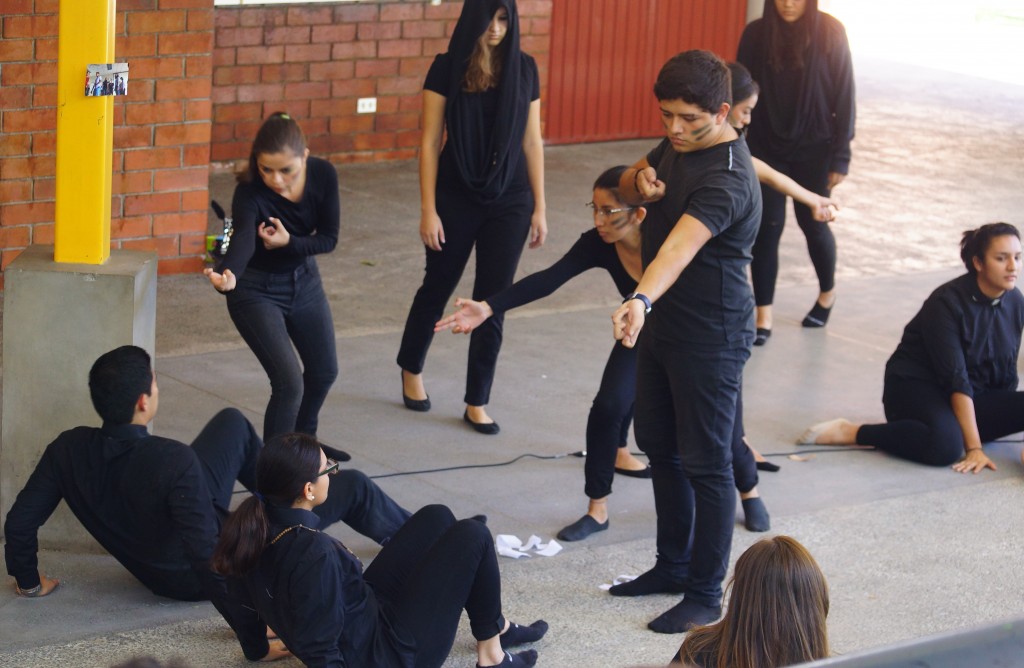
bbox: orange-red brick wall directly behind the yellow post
[0,0,214,273]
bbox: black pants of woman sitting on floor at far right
[857,378,1024,466]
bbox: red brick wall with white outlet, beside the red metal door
[211,0,552,164]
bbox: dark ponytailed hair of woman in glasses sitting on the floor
[210,433,321,576]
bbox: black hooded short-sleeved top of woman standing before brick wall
[424,0,541,204]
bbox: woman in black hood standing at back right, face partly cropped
[736,0,855,344]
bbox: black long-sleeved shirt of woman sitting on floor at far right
[886,274,1024,398]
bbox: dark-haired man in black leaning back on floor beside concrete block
[4,345,409,659]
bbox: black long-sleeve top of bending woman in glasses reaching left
[486,228,637,314]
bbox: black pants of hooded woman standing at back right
[751,144,836,306]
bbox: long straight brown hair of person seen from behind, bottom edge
[679,536,828,668]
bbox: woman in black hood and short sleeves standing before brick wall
[397,0,548,434]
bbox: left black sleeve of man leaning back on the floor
[4,442,63,589]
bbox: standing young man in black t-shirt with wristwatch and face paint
[610,51,761,633]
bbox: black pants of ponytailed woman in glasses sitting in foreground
[365,505,505,668]
